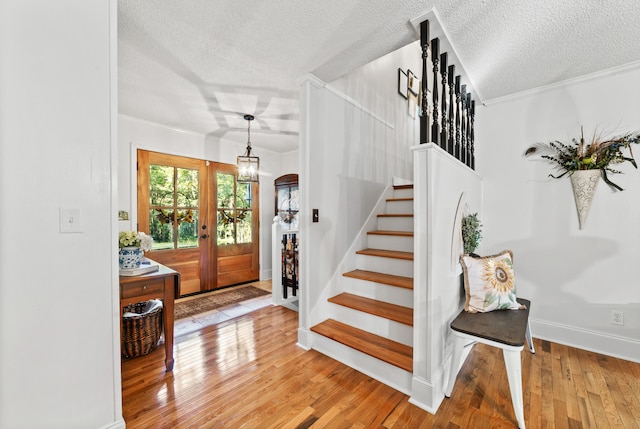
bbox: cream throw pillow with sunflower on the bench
[460,250,524,313]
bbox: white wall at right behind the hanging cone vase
[476,64,640,361]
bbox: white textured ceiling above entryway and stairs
[118,0,640,152]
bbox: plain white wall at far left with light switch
[0,0,124,429]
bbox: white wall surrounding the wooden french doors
[118,115,282,280]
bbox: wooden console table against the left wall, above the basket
[120,264,180,371]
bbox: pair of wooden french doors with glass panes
[138,150,259,295]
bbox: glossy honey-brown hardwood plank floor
[122,306,640,429]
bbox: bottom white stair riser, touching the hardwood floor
[311,332,413,395]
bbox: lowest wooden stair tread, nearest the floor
[311,319,413,372]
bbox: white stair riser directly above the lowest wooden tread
[329,303,413,346]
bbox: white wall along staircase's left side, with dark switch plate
[300,44,421,343]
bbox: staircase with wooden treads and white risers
[311,185,413,393]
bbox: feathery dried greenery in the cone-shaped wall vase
[524,125,640,191]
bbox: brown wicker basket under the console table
[122,300,162,358]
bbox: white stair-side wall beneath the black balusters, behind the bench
[409,143,482,413]
